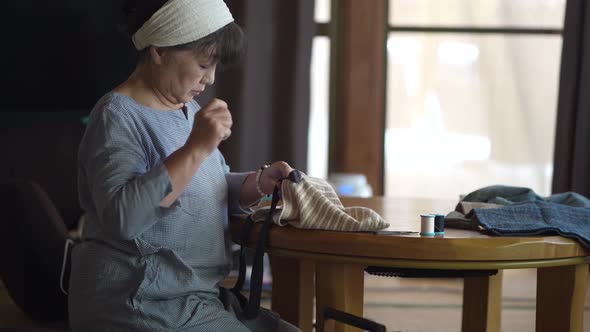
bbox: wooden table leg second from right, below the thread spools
[461,270,502,332]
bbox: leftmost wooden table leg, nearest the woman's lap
[270,256,314,332]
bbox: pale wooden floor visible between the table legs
[0,270,590,332]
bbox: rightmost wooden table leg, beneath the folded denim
[535,264,588,332]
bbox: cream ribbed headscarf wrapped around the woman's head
[132,0,234,50]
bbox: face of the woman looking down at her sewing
[153,49,217,104]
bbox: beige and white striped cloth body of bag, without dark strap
[252,175,389,232]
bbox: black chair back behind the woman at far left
[0,179,69,328]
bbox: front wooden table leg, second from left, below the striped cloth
[316,262,365,332]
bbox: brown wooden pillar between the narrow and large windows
[330,0,387,194]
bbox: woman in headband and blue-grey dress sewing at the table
[69,0,298,331]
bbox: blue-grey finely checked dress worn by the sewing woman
[69,92,252,331]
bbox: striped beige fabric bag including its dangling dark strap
[230,170,389,319]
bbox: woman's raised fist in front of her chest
[187,98,233,153]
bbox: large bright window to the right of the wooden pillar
[385,0,565,198]
